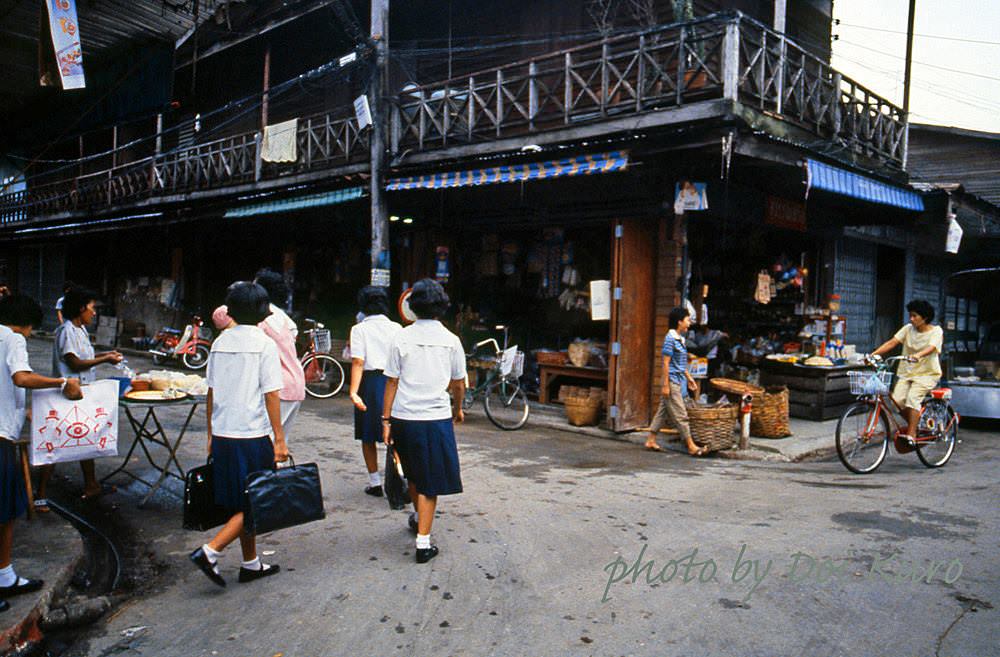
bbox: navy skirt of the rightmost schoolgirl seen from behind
[392,418,462,497]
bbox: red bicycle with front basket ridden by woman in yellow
[837,356,960,474]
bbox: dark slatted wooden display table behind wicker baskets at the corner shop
[760,360,864,421]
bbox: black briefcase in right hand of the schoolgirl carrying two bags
[243,461,326,534]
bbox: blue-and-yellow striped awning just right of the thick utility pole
[385,151,628,191]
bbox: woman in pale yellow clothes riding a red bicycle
[871,300,944,441]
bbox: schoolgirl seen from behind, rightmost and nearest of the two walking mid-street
[380,278,465,563]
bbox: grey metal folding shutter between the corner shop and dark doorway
[833,238,878,351]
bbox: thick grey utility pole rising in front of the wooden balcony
[368,0,391,287]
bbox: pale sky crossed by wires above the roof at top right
[833,0,1000,133]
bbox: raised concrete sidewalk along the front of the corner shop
[526,403,837,463]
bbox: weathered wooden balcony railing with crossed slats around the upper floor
[0,13,907,224]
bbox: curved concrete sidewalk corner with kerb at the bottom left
[0,511,84,655]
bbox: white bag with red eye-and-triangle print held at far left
[31,380,118,465]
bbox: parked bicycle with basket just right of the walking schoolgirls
[462,326,531,431]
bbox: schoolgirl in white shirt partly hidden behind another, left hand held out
[350,285,403,497]
